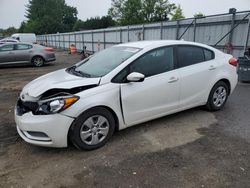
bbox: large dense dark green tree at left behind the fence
[23,0,77,34]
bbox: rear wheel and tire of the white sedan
[206,81,229,111]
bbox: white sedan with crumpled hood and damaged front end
[15,41,237,150]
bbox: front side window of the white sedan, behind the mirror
[112,47,174,83]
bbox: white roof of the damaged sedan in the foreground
[117,40,215,49]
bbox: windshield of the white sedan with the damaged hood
[75,47,140,77]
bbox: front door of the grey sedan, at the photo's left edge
[0,44,15,64]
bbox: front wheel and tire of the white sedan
[69,107,115,150]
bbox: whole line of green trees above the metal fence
[0,0,204,35]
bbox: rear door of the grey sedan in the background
[15,44,33,62]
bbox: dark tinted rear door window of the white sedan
[177,46,205,67]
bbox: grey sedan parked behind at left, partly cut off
[0,42,56,67]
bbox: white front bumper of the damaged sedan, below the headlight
[15,112,74,148]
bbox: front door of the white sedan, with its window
[118,47,180,126]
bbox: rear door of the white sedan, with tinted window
[177,45,218,108]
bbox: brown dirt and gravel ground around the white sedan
[0,52,250,188]
